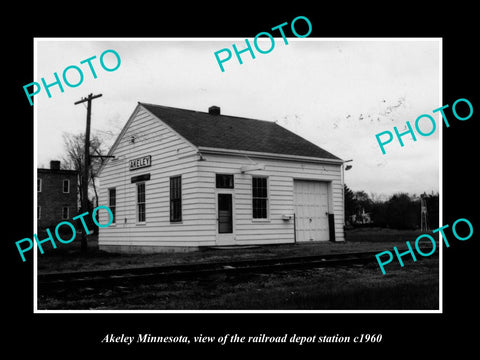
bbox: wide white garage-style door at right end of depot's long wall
[293,180,329,242]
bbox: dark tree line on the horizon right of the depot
[345,185,439,229]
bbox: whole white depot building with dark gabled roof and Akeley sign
[98,102,344,252]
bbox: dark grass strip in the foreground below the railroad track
[38,258,439,310]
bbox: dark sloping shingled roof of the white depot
[139,102,341,161]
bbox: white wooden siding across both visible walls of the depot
[99,105,344,246]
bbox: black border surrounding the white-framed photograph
[2,2,480,358]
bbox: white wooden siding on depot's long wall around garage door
[198,154,344,245]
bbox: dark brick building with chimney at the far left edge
[37,160,78,232]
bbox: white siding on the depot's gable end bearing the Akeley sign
[99,106,215,246]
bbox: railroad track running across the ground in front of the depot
[37,251,436,292]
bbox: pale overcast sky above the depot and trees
[35,38,442,195]
